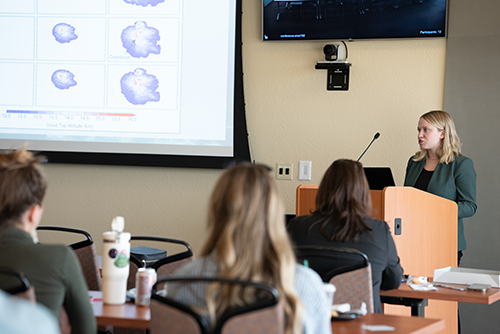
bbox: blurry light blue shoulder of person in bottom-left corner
[0,290,59,334]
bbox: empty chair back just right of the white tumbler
[127,235,194,289]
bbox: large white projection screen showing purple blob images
[0,0,250,168]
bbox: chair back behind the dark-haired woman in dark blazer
[295,245,374,313]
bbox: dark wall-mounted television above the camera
[262,0,447,41]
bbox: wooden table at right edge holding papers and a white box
[380,277,500,317]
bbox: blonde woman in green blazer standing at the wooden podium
[404,110,477,265]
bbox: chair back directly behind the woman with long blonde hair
[150,277,284,334]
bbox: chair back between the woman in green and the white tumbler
[37,226,102,291]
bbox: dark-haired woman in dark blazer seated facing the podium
[287,160,403,313]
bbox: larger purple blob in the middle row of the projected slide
[121,21,161,58]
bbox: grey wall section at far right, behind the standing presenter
[444,0,500,334]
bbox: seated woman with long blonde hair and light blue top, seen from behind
[169,164,331,334]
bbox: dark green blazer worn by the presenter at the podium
[404,156,477,251]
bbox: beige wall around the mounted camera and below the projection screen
[38,0,446,252]
